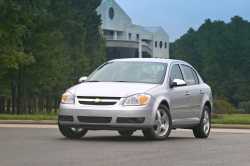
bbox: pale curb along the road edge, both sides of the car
[0,120,250,129]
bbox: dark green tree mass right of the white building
[171,16,250,106]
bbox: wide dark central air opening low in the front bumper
[77,116,112,123]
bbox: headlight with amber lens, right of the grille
[123,94,151,106]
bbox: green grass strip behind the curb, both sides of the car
[0,114,250,125]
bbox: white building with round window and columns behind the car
[97,0,169,59]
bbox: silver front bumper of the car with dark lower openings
[59,104,155,130]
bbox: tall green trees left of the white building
[0,0,105,114]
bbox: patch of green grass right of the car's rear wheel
[212,114,250,125]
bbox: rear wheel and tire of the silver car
[193,106,211,139]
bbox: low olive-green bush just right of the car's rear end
[214,99,237,114]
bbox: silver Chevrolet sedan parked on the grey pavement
[58,58,213,140]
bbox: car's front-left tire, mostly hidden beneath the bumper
[58,124,88,139]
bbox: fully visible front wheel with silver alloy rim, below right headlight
[142,105,172,140]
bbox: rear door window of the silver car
[181,65,199,85]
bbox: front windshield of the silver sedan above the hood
[87,62,167,84]
